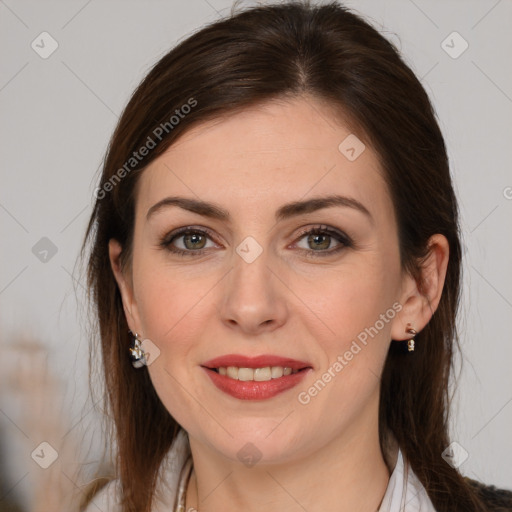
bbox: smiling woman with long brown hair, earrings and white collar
[81,2,512,512]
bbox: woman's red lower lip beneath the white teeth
[203,366,311,400]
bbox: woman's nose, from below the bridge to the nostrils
[220,251,288,335]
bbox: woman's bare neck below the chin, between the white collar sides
[185,412,397,512]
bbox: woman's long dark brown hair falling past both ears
[84,1,484,512]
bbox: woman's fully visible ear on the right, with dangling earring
[391,234,450,341]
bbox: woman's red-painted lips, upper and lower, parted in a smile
[202,354,312,400]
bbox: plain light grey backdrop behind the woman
[0,0,512,508]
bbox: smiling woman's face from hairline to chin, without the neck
[111,98,411,463]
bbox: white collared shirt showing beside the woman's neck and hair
[85,430,436,512]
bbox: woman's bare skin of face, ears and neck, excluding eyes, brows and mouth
[109,97,448,512]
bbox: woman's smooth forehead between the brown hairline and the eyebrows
[137,98,390,224]
